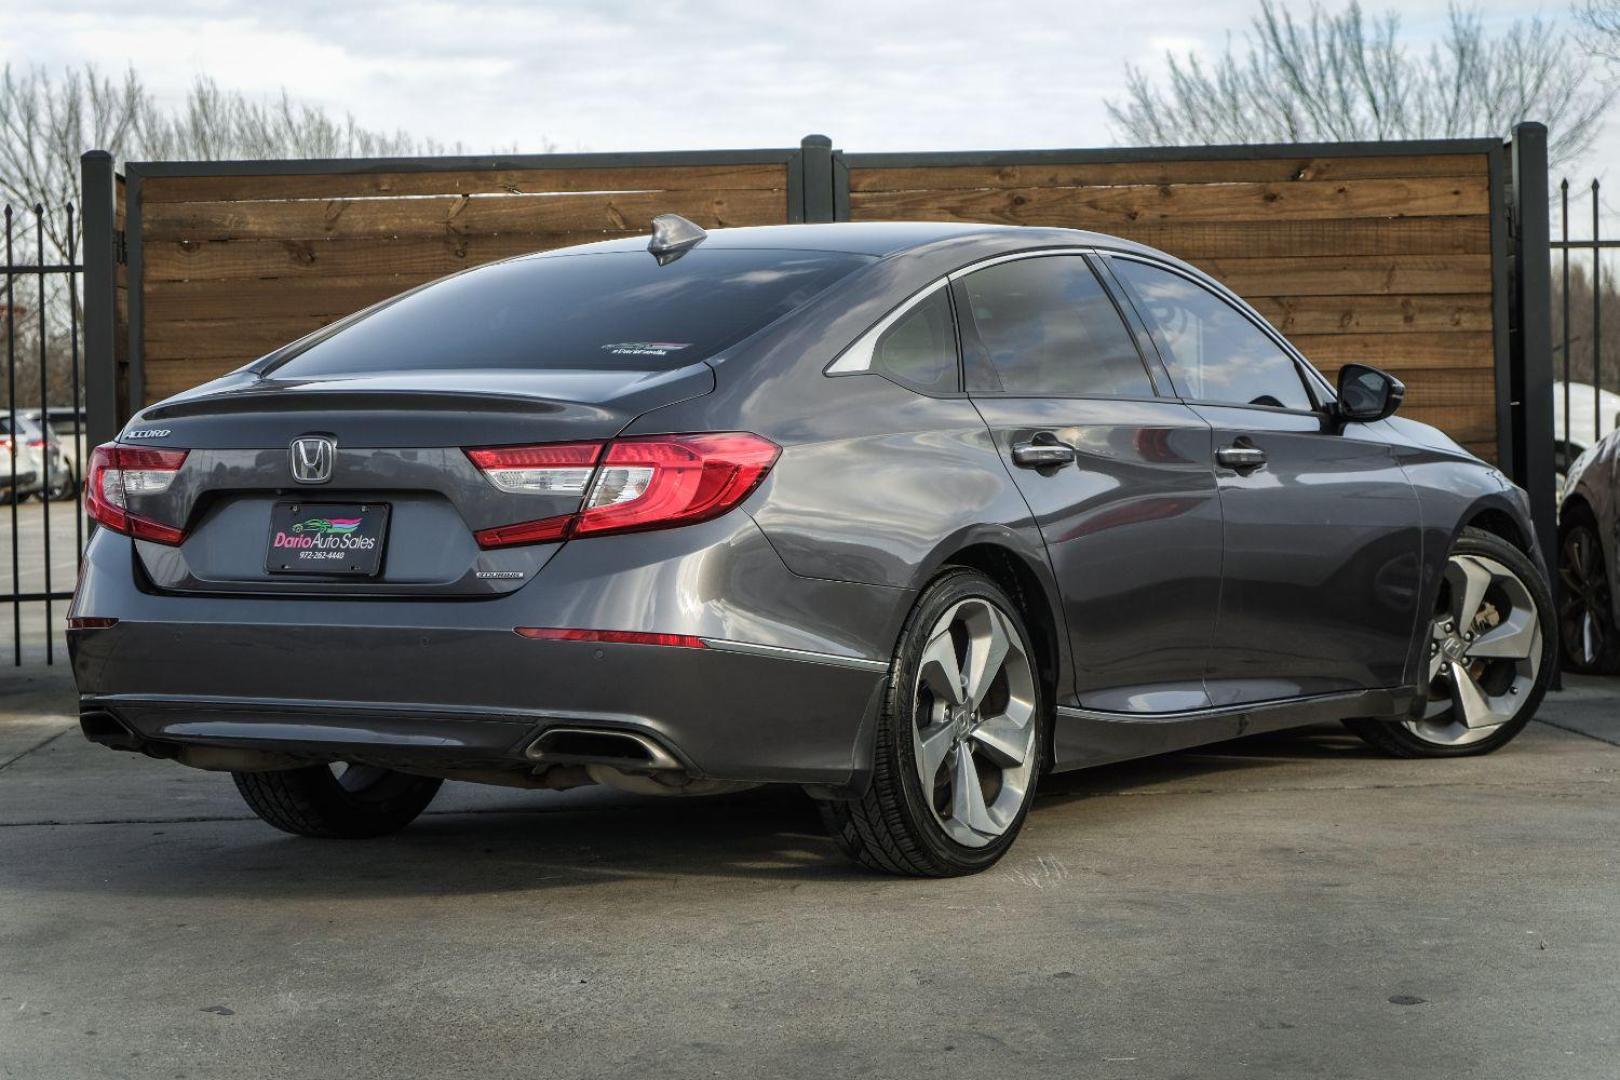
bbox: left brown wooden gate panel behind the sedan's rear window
[118,151,802,402]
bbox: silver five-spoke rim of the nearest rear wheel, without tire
[912,597,1035,847]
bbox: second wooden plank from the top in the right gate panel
[849,176,1490,230]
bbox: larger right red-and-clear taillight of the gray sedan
[467,431,781,547]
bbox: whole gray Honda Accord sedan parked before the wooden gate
[70,217,1557,876]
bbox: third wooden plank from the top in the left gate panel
[146,232,640,287]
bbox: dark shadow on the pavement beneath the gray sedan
[6,729,1380,902]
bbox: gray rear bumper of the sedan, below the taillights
[68,515,909,785]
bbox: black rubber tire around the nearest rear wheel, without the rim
[820,568,1048,878]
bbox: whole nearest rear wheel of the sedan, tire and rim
[823,570,1043,878]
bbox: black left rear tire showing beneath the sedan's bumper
[232,764,444,840]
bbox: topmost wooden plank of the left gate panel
[141,164,787,206]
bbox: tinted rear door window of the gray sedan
[961,254,1153,398]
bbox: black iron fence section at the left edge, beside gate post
[0,202,86,665]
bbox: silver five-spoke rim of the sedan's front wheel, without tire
[1406,552,1542,746]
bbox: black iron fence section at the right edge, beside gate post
[1549,180,1620,468]
